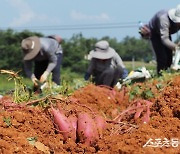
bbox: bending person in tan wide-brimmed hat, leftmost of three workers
[21,35,63,90]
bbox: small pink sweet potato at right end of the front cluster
[94,115,106,138]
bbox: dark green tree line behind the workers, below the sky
[0,29,153,74]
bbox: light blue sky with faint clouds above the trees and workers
[0,0,180,40]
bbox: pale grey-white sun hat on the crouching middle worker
[89,40,115,59]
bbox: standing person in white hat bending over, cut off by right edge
[142,5,180,75]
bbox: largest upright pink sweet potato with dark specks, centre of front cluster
[77,113,99,145]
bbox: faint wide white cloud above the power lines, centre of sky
[70,11,110,21]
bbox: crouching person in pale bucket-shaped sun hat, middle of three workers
[84,40,128,87]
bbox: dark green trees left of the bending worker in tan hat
[0,29,42,71]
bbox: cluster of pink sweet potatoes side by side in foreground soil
[51,107,106,145]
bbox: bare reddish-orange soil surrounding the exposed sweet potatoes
[0,76,180,154]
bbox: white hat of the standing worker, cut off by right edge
[168,5,180,23]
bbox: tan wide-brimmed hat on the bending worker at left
[21,36,41,60]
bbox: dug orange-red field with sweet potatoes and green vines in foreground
[0,70,180,154]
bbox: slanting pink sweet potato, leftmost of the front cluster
[52,108,76,141]
